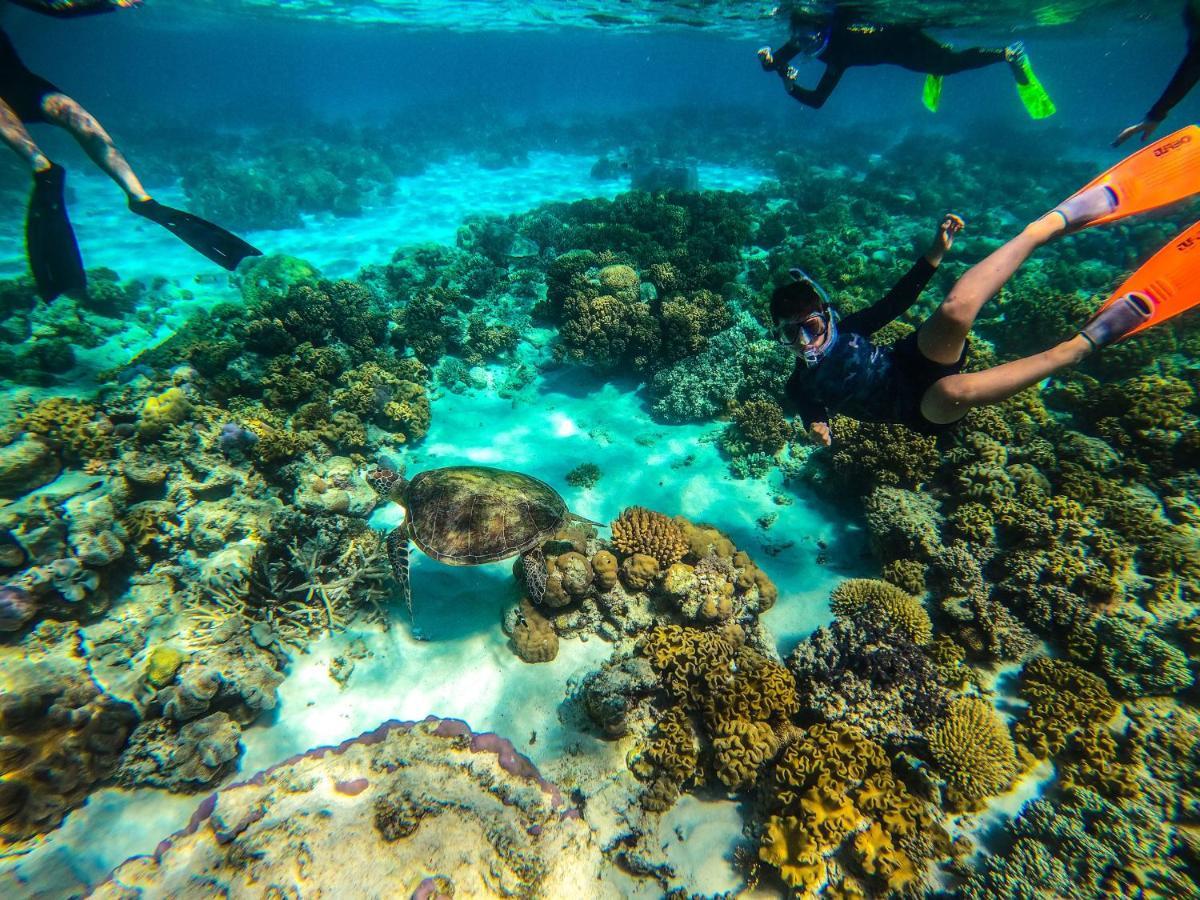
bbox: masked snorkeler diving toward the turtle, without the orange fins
[770,185,1176,446]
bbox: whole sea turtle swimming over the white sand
[367,466,602,610]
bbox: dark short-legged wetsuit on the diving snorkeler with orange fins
[785,257,967,434]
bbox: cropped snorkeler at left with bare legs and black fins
[0,0,260,301]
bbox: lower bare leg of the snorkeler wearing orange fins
[920,335,1093,425]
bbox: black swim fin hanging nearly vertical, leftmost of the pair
[25,163,88,302]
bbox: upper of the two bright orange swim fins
[1058,125,1200,230]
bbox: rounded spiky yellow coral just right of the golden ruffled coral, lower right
[929,697,1016,809]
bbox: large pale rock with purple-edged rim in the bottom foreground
[92,716,609,900]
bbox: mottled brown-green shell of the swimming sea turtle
[404,466,568,565]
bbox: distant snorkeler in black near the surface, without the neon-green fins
[758,11,1025,109]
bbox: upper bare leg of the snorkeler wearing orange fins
[917,214,1067,366]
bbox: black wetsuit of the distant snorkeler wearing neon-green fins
[772,17,1006,108]
